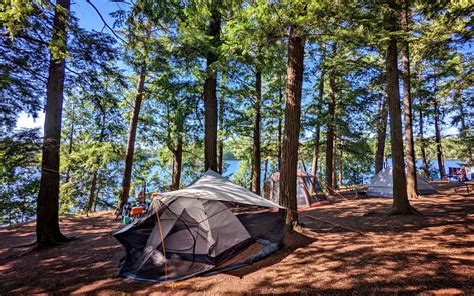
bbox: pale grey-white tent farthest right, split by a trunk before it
[367,167,436,198]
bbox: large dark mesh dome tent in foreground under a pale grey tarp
[114,171,285,282]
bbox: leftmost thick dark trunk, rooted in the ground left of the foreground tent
[36,0,71,247]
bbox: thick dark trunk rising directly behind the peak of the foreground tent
[204,0,221,172]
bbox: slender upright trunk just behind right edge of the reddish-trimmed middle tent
[326,44,337,194]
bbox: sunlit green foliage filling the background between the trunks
[0,0,473,223]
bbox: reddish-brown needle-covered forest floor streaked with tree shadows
[0,183,474,295]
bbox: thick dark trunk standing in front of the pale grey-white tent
[386,8,414,214]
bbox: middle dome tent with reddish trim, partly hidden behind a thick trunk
[266,169,329,209]
